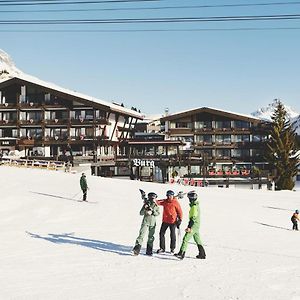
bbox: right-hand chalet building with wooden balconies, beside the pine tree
[161,107,270,177]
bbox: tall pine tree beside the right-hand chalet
[266,100,299,190]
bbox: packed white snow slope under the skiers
[0,166,300,300]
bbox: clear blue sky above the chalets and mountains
[0,0,300,114]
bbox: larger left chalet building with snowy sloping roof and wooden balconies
[0,75,143,160]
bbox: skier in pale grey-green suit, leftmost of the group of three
[132,192,159,256]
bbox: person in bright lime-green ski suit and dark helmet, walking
[175,191,206,259]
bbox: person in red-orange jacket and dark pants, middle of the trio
[156,190,182,253]
